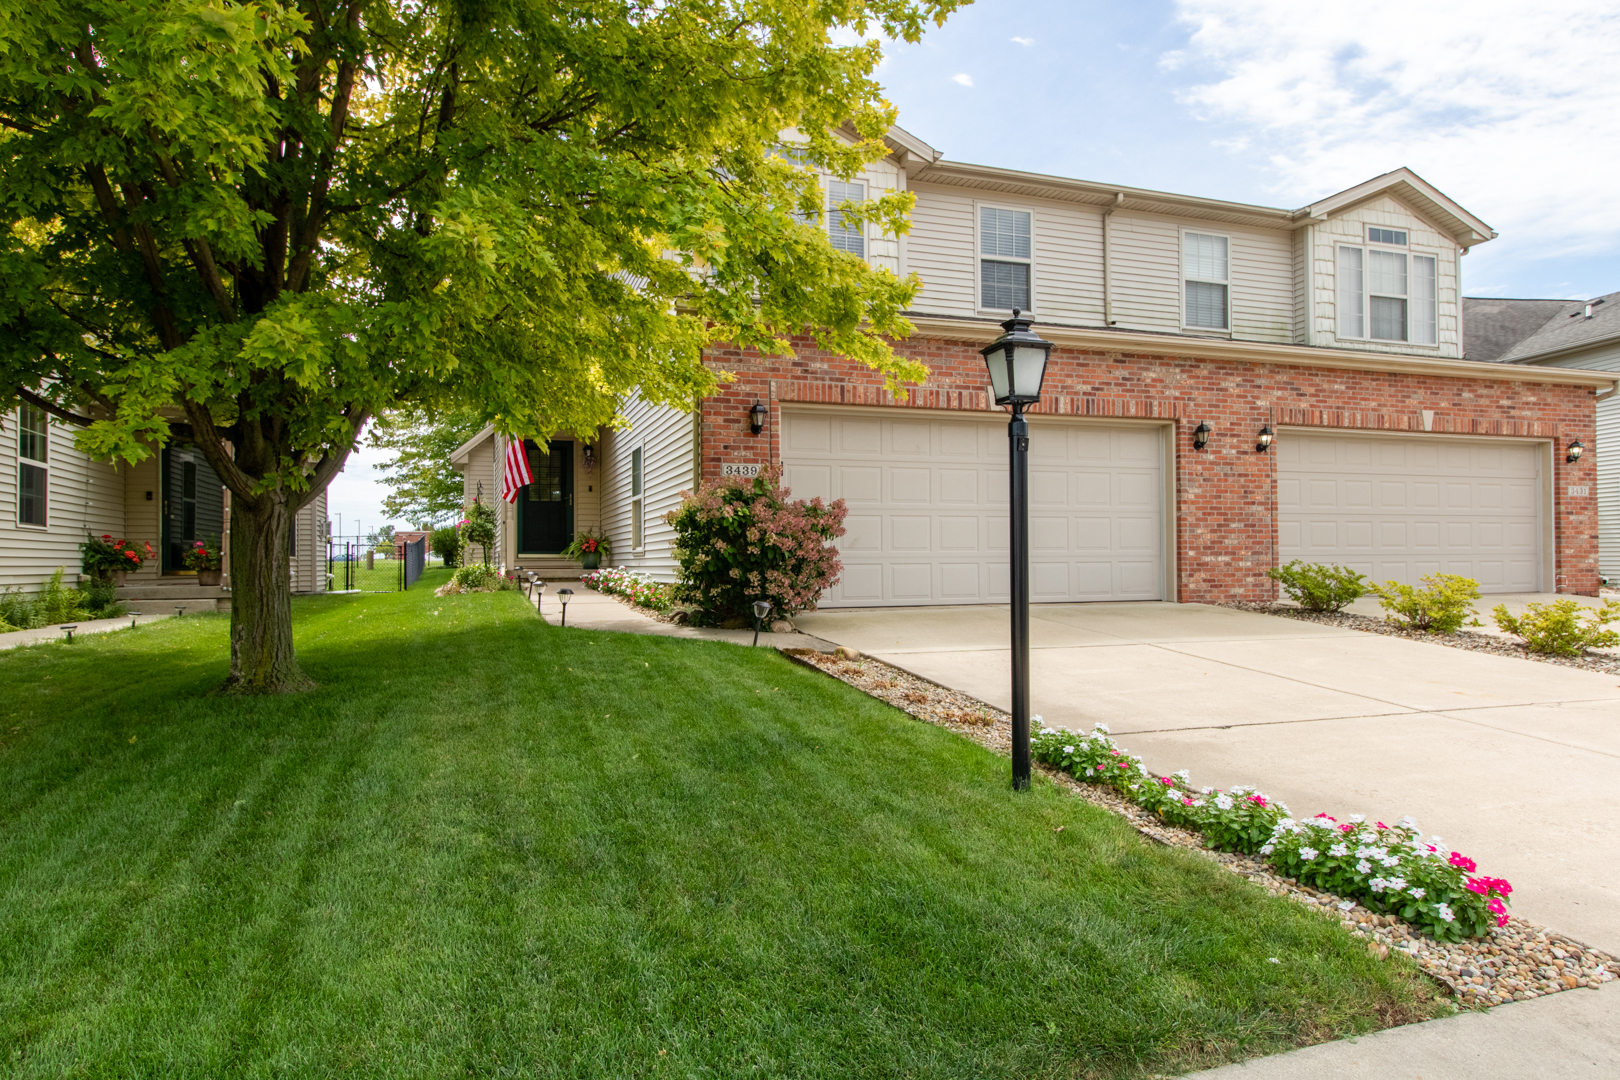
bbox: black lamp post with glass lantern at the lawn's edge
[978,309,1051,790]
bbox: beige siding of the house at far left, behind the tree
[0,410,125,591]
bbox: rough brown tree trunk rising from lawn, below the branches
[225,491,314,693]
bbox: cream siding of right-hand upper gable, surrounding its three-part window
[1312,196,1461,356]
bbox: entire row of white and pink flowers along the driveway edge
[1030,716,1513,941]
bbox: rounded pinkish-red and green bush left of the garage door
[664,468,846,622]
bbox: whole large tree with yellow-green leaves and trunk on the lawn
[0,0,962,690]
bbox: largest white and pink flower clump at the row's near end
[1260,814,1513,941]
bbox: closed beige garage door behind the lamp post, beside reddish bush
[782,410,1165,607]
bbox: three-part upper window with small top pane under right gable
[1338,238,1439,345]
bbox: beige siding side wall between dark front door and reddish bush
[596,395,697,581]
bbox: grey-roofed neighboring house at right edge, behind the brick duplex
[1463,293,1620,583]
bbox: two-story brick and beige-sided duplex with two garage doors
[455,130,1614,606]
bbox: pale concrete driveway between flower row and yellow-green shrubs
[795,604,1620,954]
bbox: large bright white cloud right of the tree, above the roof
[1160,0,1620,265]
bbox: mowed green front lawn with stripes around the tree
[0,570,1445,1078]
